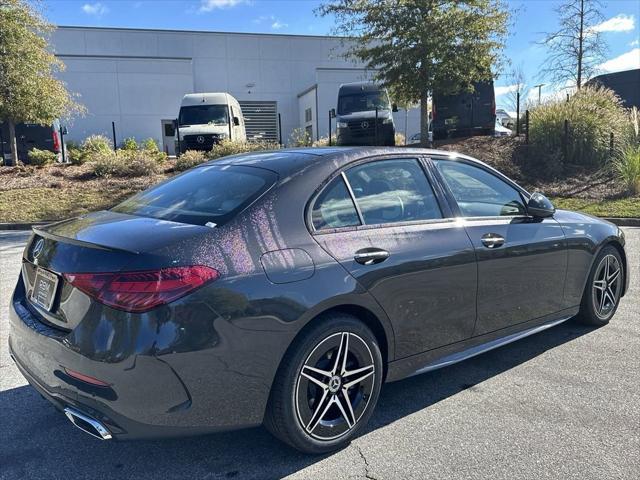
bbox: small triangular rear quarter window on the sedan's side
[311,176,360,230]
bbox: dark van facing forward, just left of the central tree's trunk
[336,82,398,146]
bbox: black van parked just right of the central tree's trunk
[431,82,496,140]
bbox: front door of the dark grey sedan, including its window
[433,158,567,335]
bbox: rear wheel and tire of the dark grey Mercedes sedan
[264,314,383,454]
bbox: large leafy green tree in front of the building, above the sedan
[317,0,509,144]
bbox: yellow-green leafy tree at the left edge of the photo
[0,0,84,163]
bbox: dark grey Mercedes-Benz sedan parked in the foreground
[9,148,629,453]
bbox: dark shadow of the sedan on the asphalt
[0,322,592,479]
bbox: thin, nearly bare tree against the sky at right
[540,0,607,90]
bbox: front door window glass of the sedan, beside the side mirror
[435,160,526,217]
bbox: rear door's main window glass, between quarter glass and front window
[346,159,442,225]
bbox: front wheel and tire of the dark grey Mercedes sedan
[576,245,625,327]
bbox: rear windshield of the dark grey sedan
[112,165,277,226]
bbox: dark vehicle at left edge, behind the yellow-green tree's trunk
[0,120,66,165]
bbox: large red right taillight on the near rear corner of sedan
[64,265,220,313]
